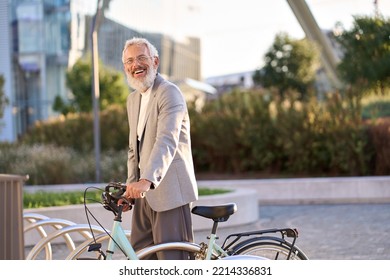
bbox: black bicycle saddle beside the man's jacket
[191,203,237,222]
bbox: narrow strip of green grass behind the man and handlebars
[23,188,231,209]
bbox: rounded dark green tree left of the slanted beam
[253,33,319,97]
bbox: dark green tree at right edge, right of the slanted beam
[336,16,390,94]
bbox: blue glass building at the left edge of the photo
[0,0,85,142]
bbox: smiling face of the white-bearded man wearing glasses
[123,44,159,92]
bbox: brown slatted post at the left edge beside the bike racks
[0,174,28,260]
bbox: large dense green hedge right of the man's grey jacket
[191,91,375,176]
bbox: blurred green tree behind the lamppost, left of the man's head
[53,59,128,115]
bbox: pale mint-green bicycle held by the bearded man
[67,182,308,260]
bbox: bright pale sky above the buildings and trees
[106,0,390,79]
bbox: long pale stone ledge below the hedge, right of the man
[198,176,390,205]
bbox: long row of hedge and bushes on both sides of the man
[0,88,390,184]
